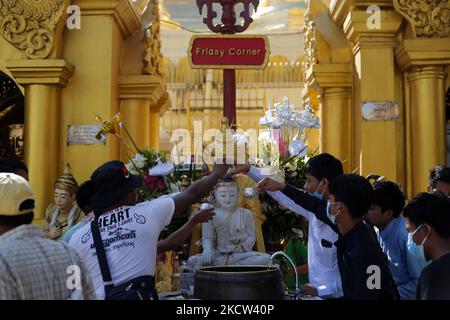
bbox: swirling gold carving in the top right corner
[394,0,450,38]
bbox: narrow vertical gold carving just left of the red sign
[144,0,164,76]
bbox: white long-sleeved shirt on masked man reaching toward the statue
[248,167,344,298]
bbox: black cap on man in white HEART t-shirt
[91,160,142,212]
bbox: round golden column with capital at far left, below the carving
[7,59,74,224]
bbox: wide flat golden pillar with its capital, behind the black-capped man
[60,0,143,182]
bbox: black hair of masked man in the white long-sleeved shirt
[305,153,344,182]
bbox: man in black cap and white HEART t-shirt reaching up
[69,161,229,299]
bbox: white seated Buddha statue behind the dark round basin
[188,177,270,269]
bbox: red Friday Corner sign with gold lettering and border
[188,35,270,70]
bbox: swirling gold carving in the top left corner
[0,0,66,59]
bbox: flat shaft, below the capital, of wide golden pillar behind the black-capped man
[60,15,122,182]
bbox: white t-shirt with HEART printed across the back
[69,198,175,299]
